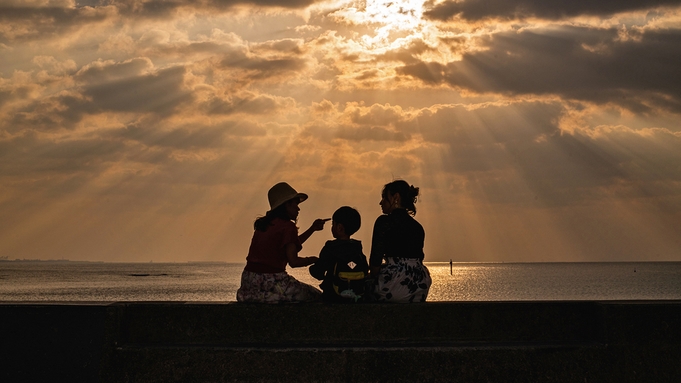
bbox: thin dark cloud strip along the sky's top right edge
[424,0,681,21]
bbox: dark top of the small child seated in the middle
[310,239,369,292]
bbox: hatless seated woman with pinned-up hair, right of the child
[369,180,431,303]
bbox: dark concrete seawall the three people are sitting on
[0,301,681,383]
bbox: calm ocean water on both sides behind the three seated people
[0,261,681,302]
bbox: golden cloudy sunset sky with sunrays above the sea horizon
[0,0,681,262]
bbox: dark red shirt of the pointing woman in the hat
[246,218,303,273]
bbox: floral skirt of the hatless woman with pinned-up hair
[374,258,432,303]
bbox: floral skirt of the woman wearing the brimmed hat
[236,270,322,303]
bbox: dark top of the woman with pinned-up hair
[369,209,426,267]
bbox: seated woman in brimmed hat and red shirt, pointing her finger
[236,182,326,303]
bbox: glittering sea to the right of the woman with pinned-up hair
[430,262,681,301]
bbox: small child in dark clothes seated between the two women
[310,206,369,303]
